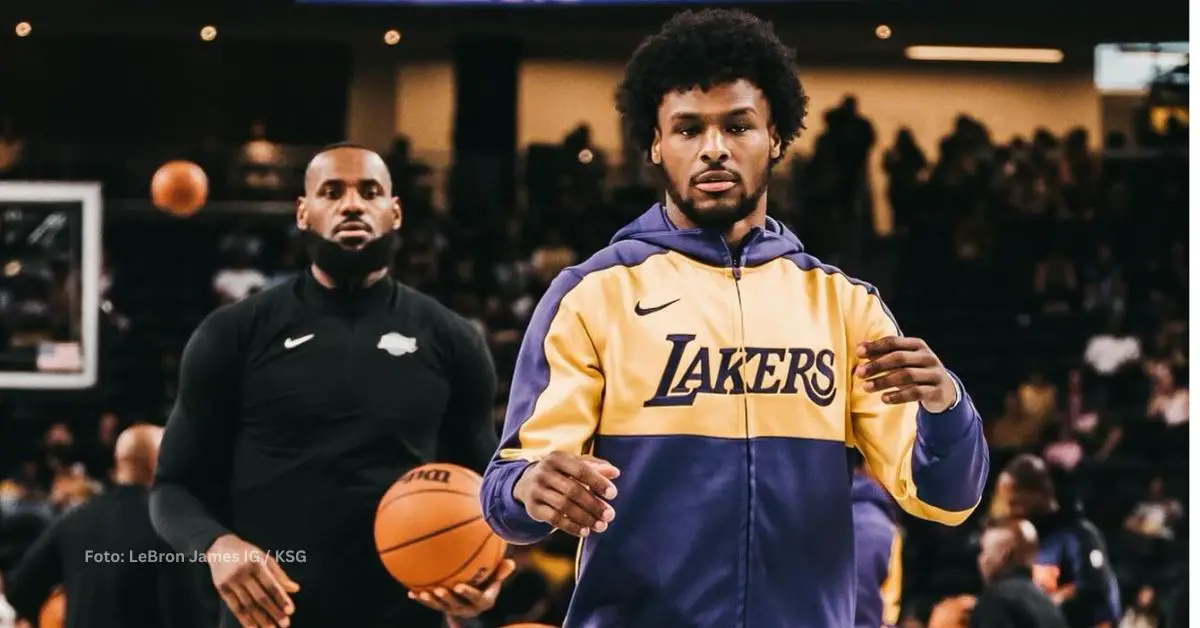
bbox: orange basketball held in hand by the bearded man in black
[374,463,508,592]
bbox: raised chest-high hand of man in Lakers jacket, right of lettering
[854,336,959,414]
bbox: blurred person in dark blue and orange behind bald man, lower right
[991,454,1121,628]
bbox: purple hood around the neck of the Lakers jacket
[610,203,804,267]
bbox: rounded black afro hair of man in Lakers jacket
[617,8,809,164]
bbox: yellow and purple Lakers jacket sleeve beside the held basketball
[481,269,605,544]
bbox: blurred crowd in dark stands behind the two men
[0,93,1189,628]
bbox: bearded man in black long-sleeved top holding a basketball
[150,144,514,628]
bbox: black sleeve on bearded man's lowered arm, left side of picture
[150,307,240,554]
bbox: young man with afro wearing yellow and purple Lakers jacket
[482,11,988,628]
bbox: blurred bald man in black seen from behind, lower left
[8,425,217,628]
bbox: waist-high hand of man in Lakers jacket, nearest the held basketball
[512,451,620,538]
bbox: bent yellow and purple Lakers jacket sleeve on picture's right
[847,285,989,526]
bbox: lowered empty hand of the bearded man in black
[205,534,300,628]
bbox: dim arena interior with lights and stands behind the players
[0,0,1189,626]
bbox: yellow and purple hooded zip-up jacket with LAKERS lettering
[481,205,989,628]
